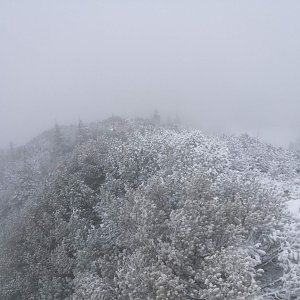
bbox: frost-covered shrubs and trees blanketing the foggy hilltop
[0,115,300,300]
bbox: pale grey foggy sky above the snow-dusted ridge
[0,0,300,147]
